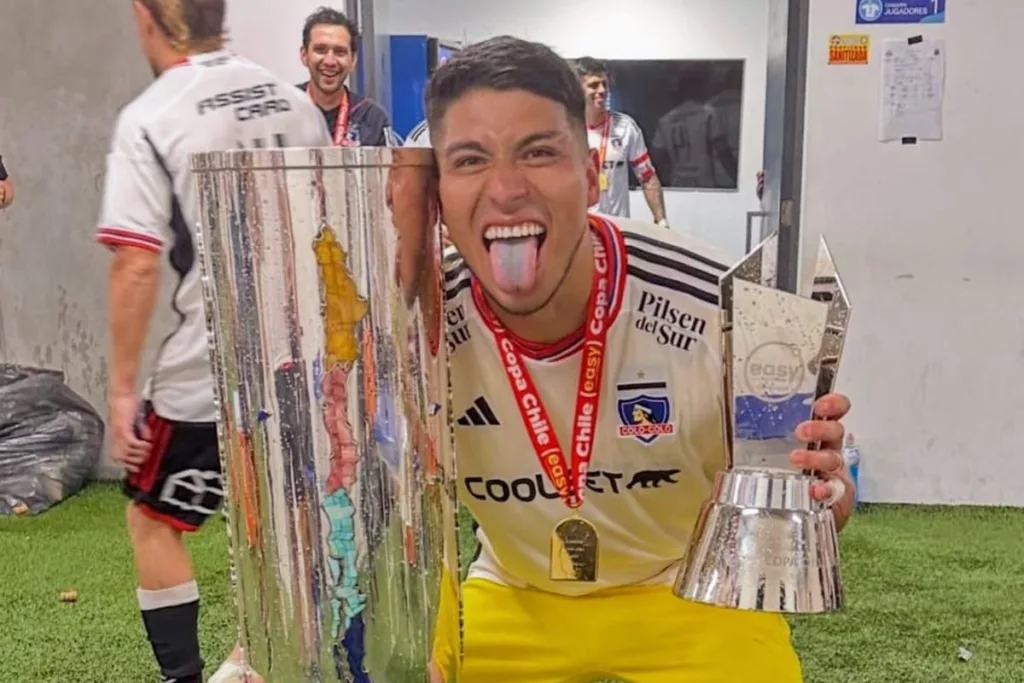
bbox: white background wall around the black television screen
[390,0,768,257]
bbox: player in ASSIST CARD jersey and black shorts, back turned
[97,0,331,683]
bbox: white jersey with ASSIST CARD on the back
[96,51,331,422]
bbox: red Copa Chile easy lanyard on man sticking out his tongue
[473,232,614,510]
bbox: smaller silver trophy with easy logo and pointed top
[675,234,850,613]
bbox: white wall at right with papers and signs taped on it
[803,0,1024,505]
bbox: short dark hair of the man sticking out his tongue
[426,36,587,137]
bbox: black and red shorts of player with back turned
[122,403,224,531]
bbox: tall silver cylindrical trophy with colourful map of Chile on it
[193,147,461,683]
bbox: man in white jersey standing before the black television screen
[575,57,669,227]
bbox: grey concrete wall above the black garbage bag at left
[0,0,170,475]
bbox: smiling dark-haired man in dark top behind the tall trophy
[299,7,392,146]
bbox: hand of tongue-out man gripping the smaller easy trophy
[790,393,854,528]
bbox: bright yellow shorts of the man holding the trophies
[434,579,803,683]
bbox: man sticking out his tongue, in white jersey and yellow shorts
[427,37,853,683]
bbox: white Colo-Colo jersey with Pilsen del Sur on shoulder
[444,215,729,595]
